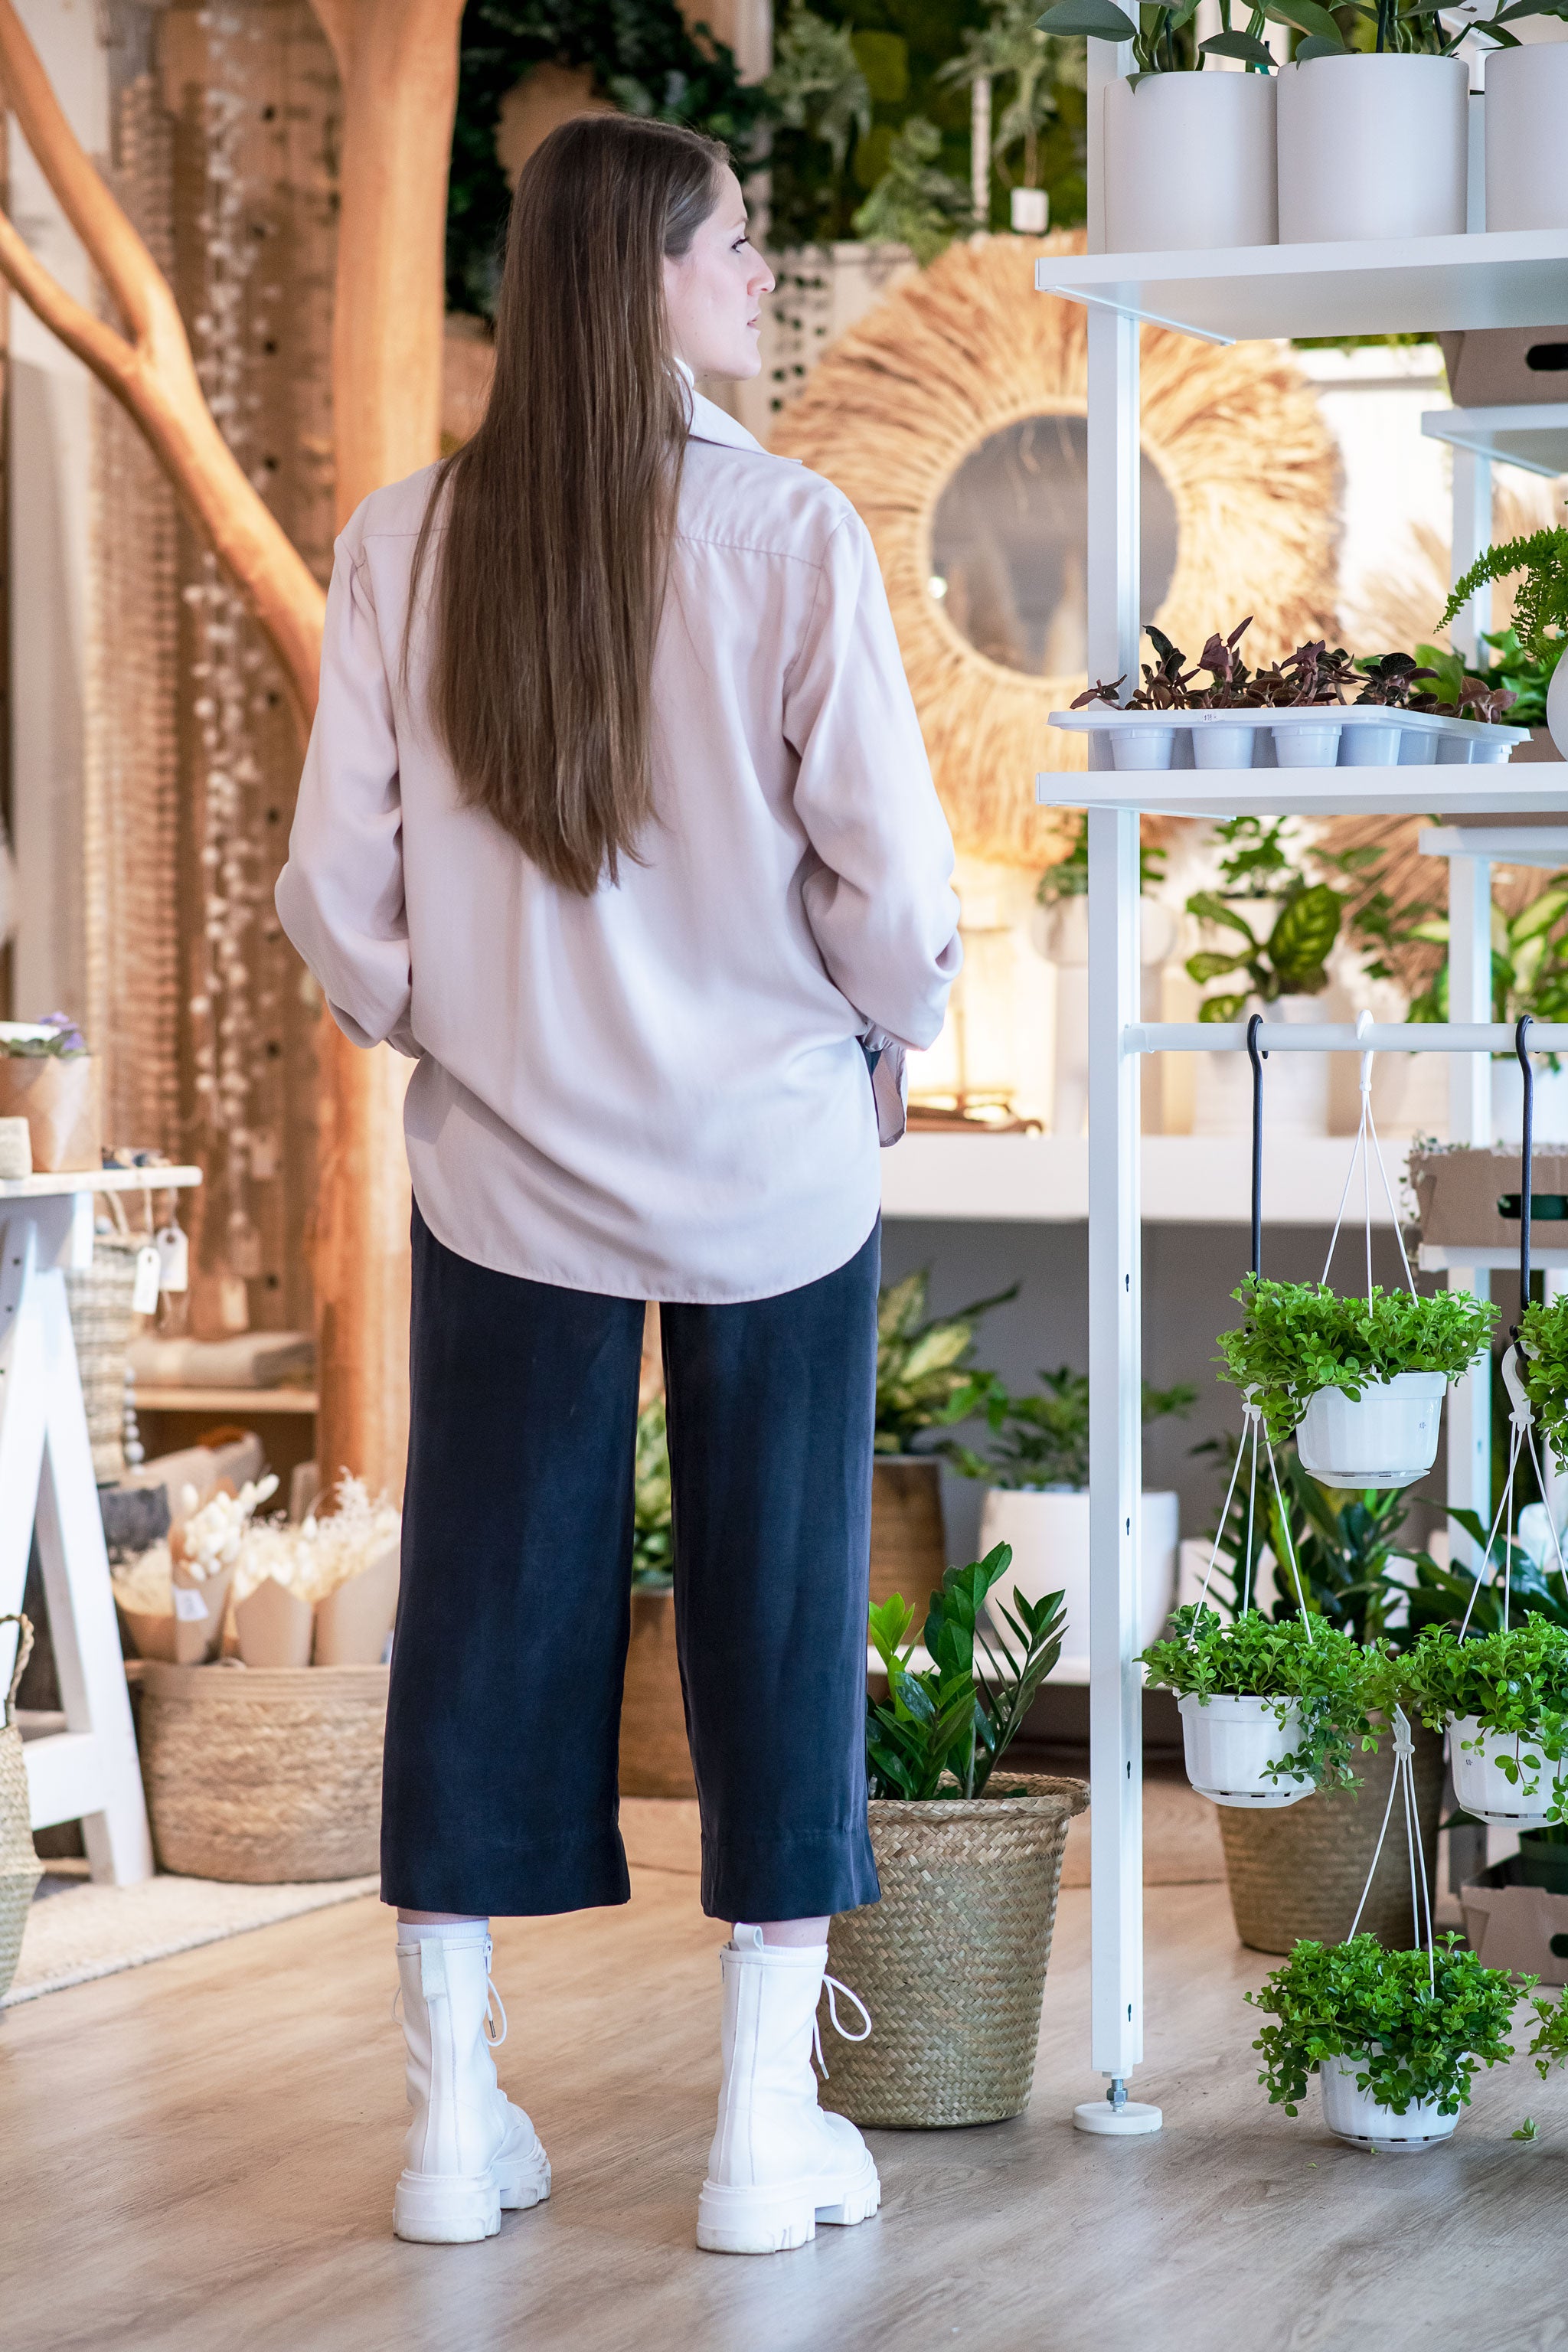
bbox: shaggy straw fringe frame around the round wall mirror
[771,233,1340,868]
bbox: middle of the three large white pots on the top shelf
[1279,52,1469,244]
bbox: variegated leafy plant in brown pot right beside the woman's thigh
[872,1268,1018,1599]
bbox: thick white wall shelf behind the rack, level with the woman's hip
[881,1136,1410,1226]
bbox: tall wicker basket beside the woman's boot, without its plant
[821,1766,1089,2131]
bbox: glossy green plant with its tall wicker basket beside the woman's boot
[823,1543,1089,2128]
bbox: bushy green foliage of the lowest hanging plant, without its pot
[1243,1936,1535,2115]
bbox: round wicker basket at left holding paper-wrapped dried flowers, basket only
[141,1663,390,1884]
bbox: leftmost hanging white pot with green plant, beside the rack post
[1142,1604,1382,1808]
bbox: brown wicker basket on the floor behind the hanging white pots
[1220,1724,1443,1952]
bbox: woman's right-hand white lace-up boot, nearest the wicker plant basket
[696,1929,881,2253]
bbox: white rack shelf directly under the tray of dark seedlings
[1034,760,1568,823]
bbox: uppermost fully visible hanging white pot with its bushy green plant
[1220,1275,1498,1489]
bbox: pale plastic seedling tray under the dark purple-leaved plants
[1050,706,1530,772]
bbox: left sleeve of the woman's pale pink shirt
[275,524,419,1060]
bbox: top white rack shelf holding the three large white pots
[1034,228,1568,344]
